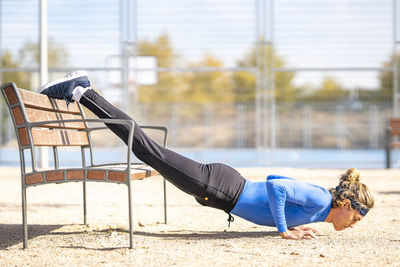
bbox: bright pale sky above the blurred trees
[0,0,398,88]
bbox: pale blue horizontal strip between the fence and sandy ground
[0,147,400,169]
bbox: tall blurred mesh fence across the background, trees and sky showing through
[0,0,399,157]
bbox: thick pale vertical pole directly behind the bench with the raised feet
[39,0,49,169]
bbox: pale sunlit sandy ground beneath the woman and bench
[0,168,400,266]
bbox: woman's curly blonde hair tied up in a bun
[329,168,375,213]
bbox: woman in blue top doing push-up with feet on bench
[38,71,374,239]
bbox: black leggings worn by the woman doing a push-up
[80,89,245,212]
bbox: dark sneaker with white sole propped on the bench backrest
[37,70,90,102]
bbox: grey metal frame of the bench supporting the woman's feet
[1,83,168,249]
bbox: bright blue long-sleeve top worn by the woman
[231,175,332,232]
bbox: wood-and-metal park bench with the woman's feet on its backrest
[1,83,167,248]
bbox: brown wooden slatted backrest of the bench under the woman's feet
[2,83,89,149]
